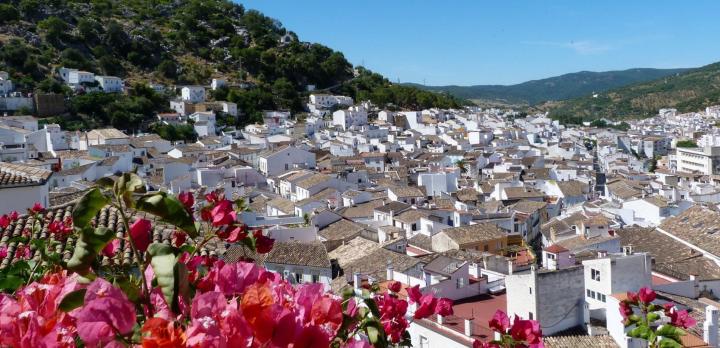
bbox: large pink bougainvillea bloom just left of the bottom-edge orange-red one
[74,278,135,346]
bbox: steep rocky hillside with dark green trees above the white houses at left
[0,0,459,129]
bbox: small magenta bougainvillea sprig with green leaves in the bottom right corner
[620,288,696,348]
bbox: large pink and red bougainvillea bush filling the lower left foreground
[0,173,542,347]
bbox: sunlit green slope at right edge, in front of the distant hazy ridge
[544,63,720,123]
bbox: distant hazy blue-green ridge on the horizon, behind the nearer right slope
[412,69,688,105]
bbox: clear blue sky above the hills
[239,0,720,85]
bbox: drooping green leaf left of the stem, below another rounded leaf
[67,227,115,275]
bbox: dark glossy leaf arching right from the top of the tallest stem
[136,192,198,238]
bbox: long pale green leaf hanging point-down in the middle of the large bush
[148,243,187,308]
